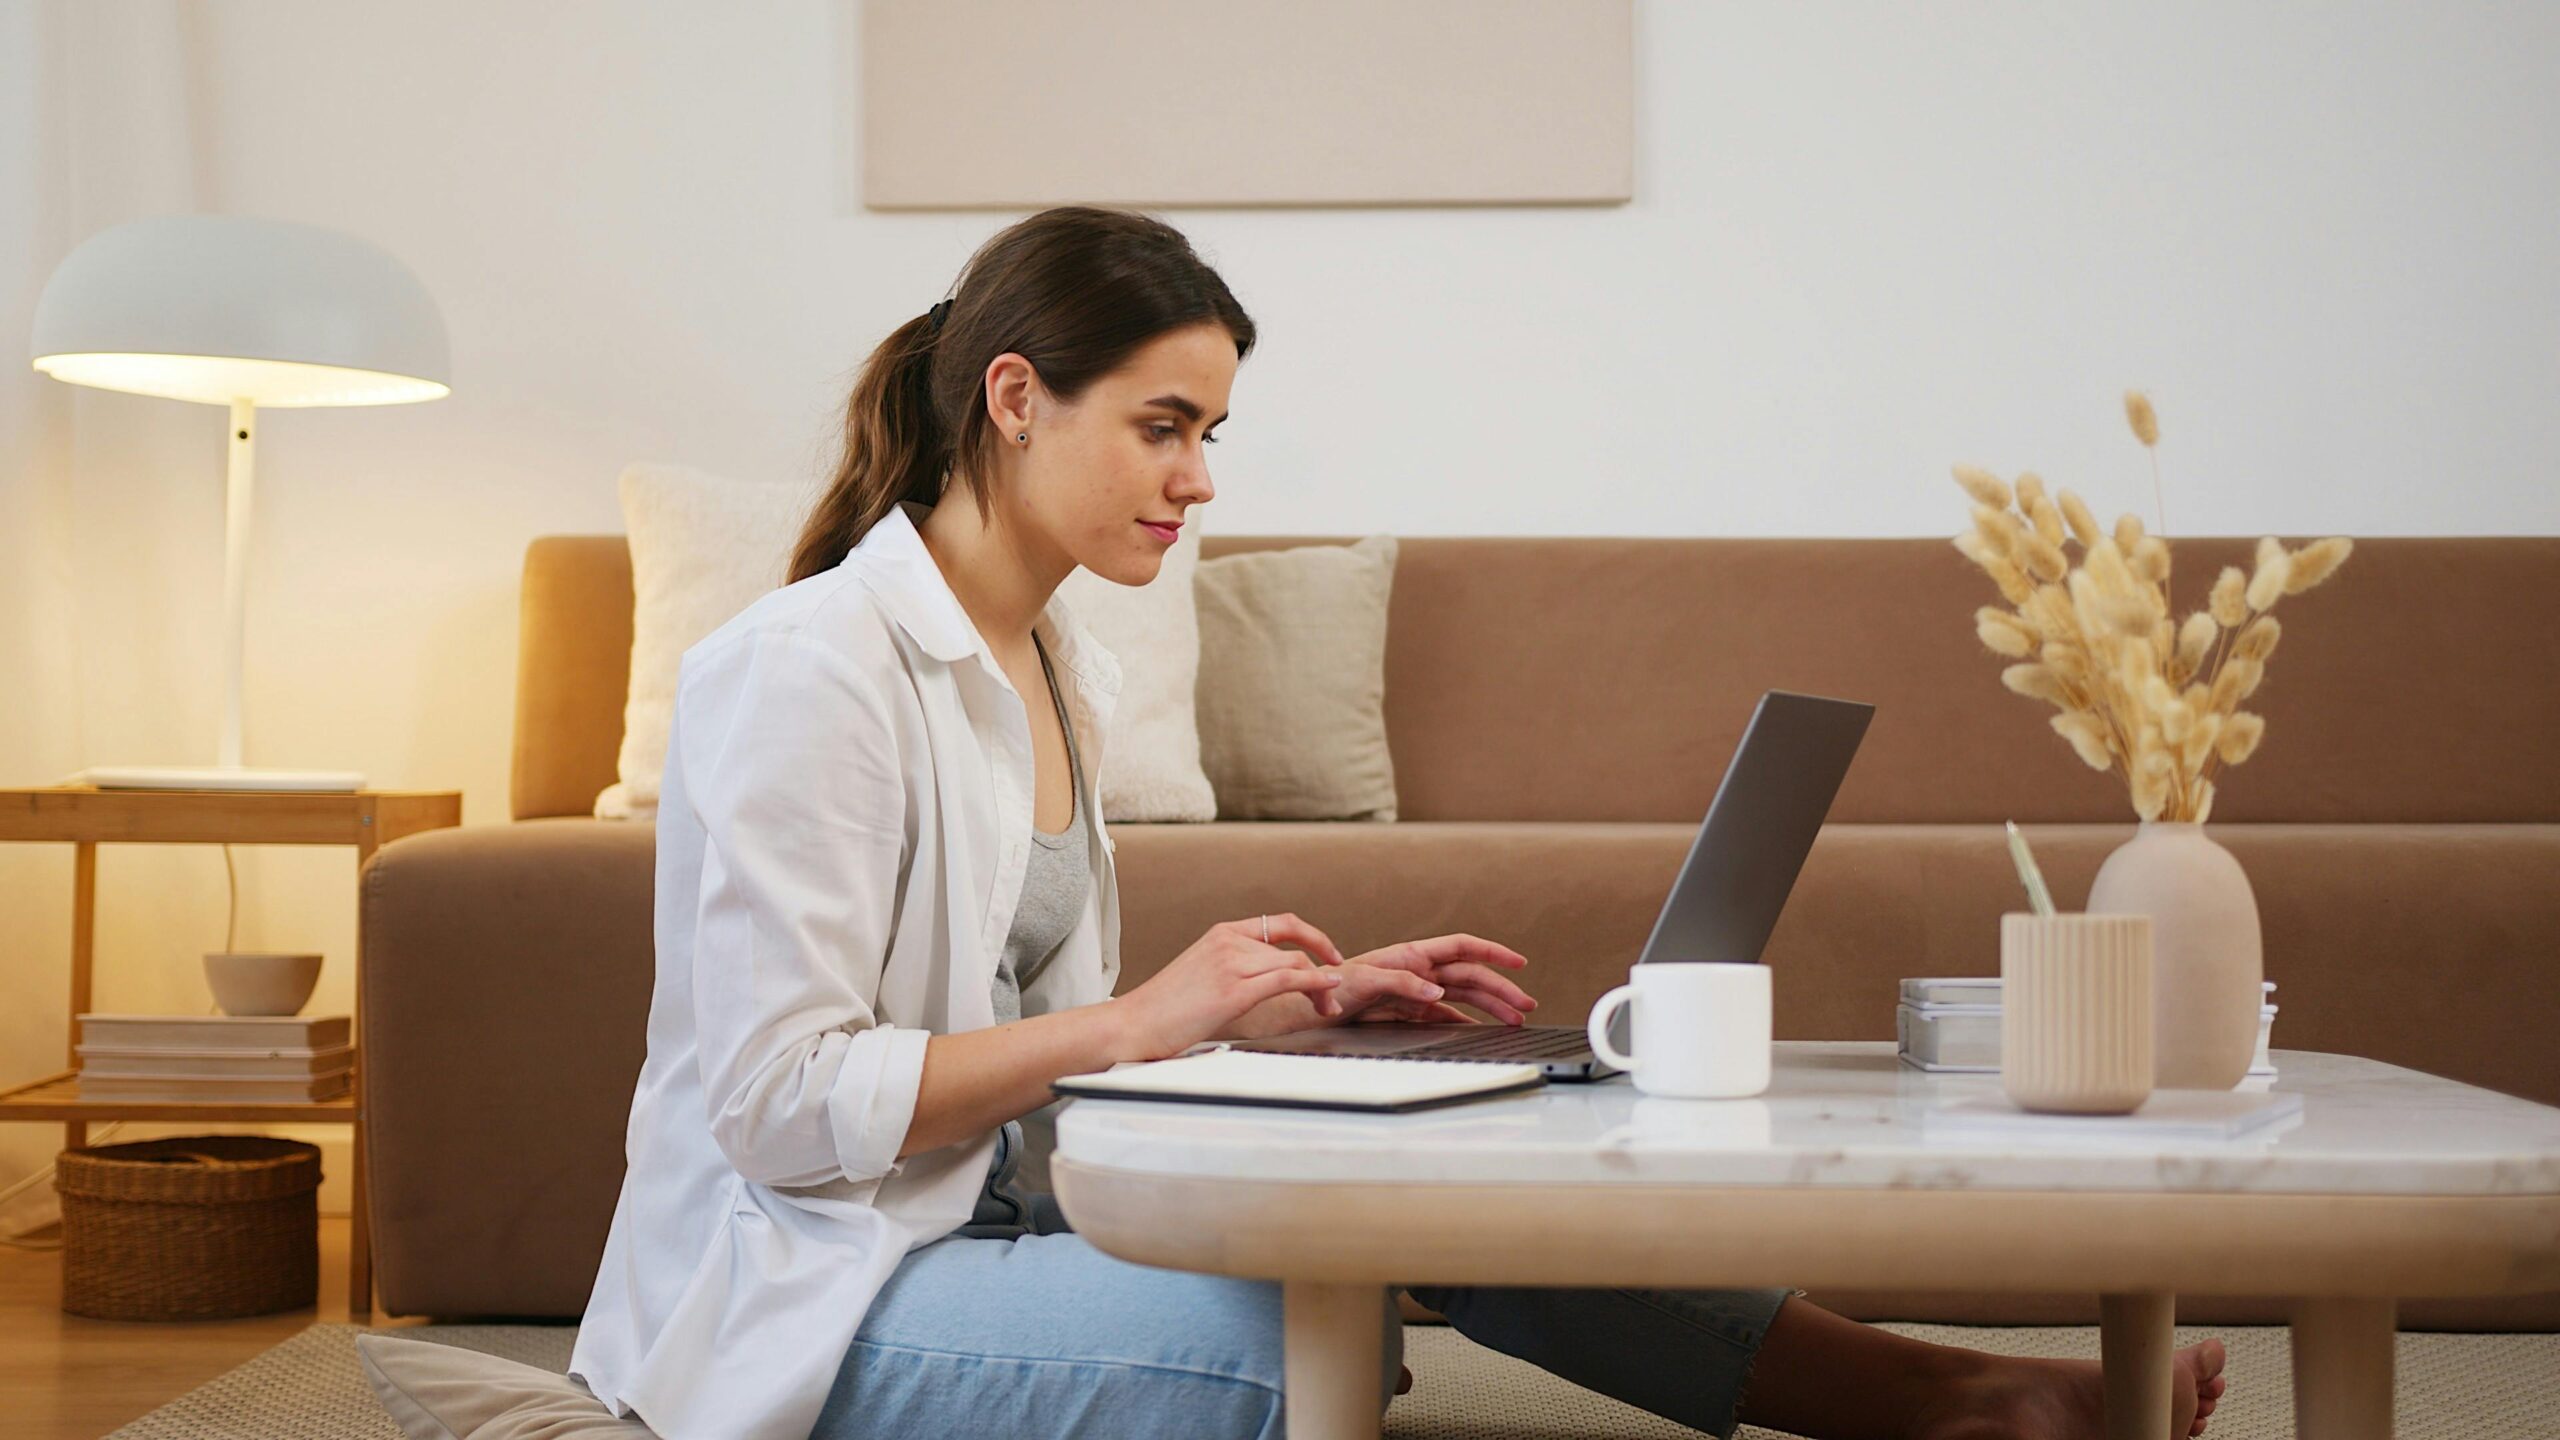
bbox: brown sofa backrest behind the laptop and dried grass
[1201,532,2560,825]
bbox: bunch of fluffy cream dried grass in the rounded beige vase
[1956,389,2355,822]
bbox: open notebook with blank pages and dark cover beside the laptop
[1050,1051,1546,1109]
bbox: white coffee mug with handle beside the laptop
[1587,961,1772,1099]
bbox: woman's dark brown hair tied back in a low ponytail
[791,205,1254,582]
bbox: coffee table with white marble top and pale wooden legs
[1050,1040,2560,1440]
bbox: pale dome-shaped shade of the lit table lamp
[31,215,451,407]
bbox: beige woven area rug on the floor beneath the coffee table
[113,1325,2560,1440]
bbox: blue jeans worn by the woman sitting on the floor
[812,1125,1797,1440]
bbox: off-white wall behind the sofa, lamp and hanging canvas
[0,0,2560,1209]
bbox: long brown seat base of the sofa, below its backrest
[358,820,2560,1330]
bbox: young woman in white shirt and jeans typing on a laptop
[571,208,2222,1440]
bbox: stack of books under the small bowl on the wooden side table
[79,1015,356,1104]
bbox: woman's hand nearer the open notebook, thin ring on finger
[1111,915,1344,1061]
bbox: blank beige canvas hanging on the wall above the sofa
[837,0,1636,210]
